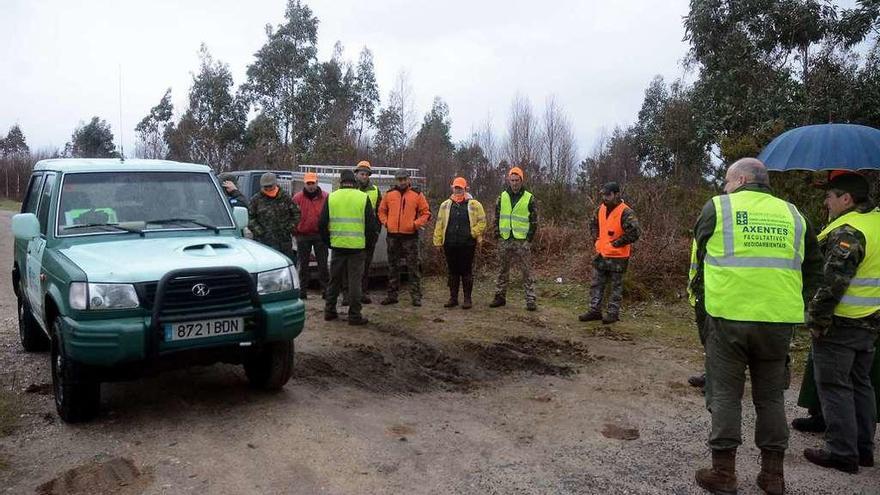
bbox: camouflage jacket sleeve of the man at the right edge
[807,205,880,331]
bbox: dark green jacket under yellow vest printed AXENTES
[690,184,822,324]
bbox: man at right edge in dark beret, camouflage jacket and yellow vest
[804,173,880,473]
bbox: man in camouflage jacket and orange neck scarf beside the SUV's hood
[248,172,300,262]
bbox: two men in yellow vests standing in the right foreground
[689,158,880,494]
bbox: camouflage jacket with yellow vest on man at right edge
[808,204,880,331]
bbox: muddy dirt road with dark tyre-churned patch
[0,212,880,494]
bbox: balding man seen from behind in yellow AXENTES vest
[691,158,822,494]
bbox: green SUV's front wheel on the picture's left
[51,316,101,423]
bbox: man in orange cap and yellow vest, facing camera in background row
[489,167,538,311]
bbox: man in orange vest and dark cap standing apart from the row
[578,182,639,324]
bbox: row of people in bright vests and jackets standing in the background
[234,161,639,325]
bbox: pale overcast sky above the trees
[0,0,688,161]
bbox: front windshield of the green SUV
[58,172,233,235]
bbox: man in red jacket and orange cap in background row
[293,172,330,299]
